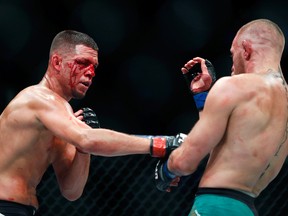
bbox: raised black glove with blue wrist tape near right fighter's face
[183,59,216,111]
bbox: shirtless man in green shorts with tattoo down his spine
[155,19,288,216]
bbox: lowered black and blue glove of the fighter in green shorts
[155,159,176,191]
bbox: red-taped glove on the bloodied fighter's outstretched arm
[150,133,187,158]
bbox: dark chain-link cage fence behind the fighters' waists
[37,155,288,216]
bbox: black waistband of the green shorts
[196,187,255,207]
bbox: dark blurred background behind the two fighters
[0,0,288,216]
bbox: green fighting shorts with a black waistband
[189,188,258,216]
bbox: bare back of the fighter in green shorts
[200,72,288,196]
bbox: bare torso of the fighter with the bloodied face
[0,86,71,206]
